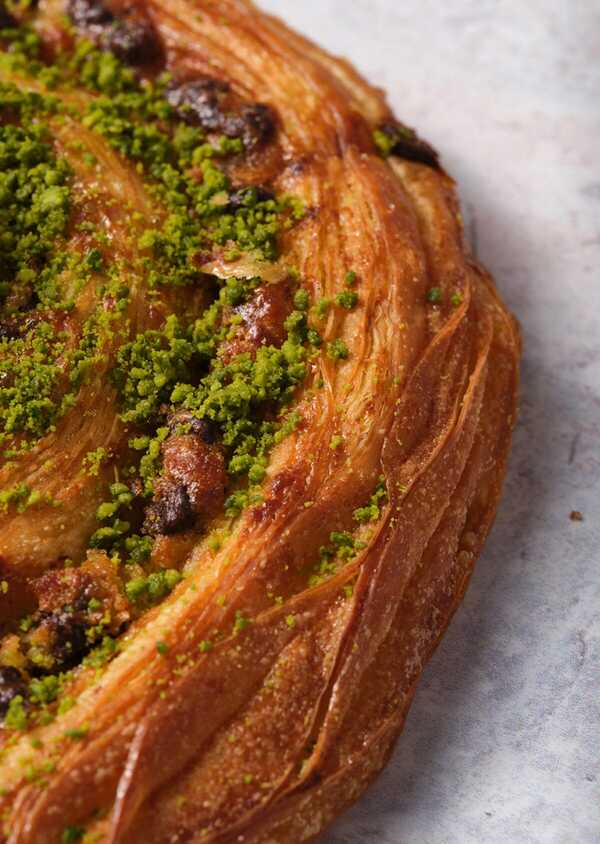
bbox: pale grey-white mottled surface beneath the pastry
[262,0,600,844]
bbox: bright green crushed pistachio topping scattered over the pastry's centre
[0,13,362,732]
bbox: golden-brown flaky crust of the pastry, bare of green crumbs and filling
[0,0,520,844]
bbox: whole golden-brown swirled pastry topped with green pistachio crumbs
[0,0,519,844]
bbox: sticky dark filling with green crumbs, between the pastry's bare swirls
[0,9,310,729]
